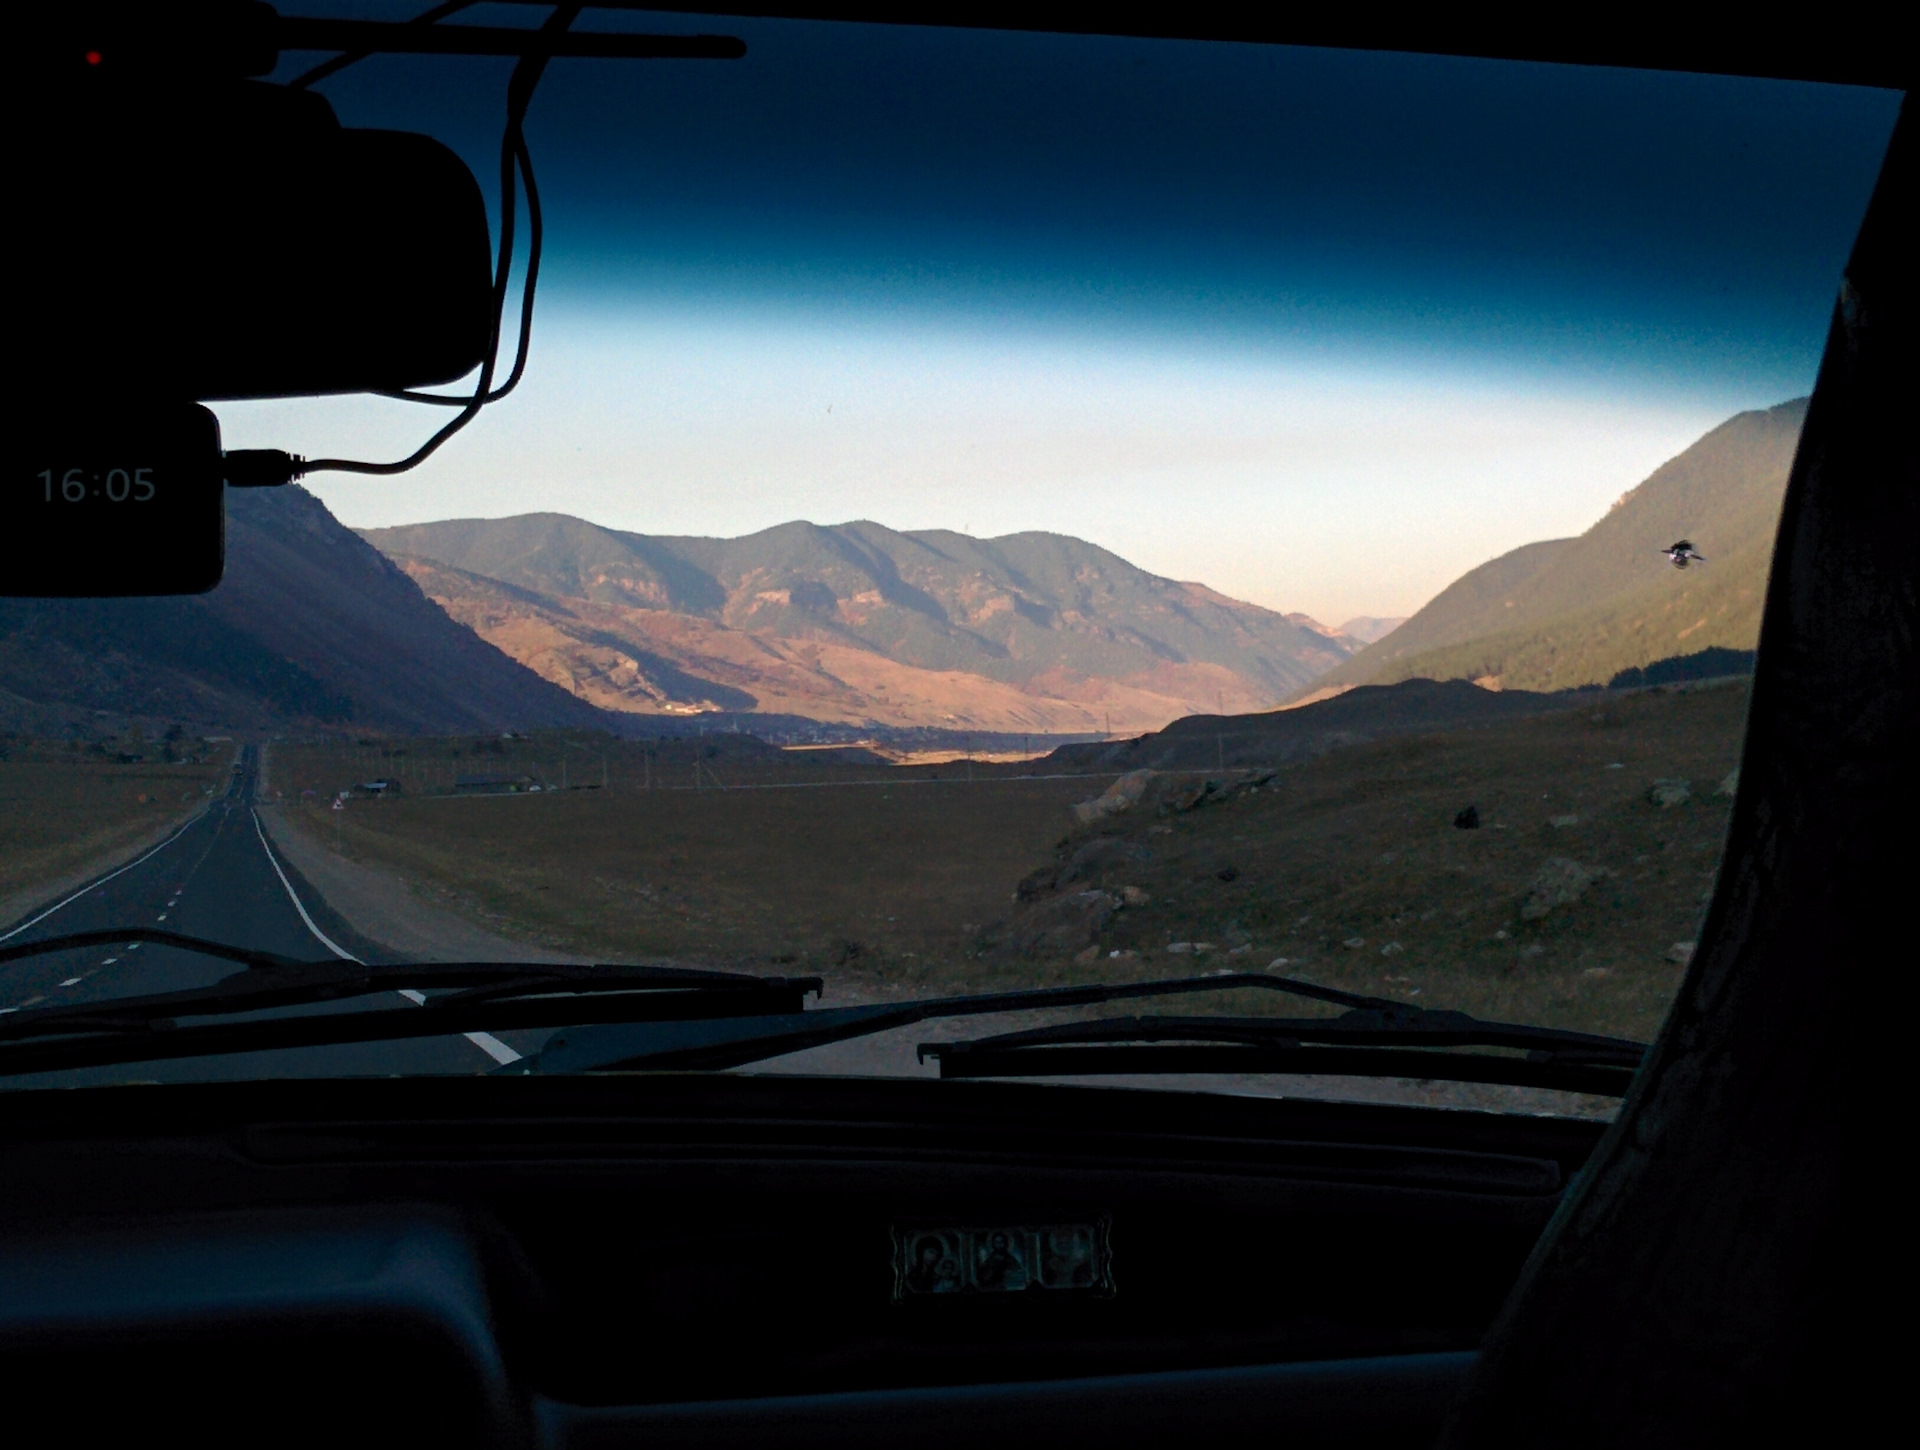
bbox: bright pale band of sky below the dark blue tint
[221,309,1751,624]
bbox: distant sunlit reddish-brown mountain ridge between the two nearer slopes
[363,513,1356,734]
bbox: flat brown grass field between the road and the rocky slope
[273,736,1113,974]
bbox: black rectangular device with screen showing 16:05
[0,403,227,599]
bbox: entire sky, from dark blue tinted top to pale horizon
[221,4,1897,622]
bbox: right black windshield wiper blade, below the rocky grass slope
[918,1008,1647,1097]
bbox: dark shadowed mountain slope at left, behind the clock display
[0,486,605,732]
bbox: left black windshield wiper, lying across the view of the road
[0,928,820,1075]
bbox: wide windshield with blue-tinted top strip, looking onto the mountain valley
[0,4,1897,1114]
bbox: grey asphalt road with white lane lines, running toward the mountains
[0,747,526,1087]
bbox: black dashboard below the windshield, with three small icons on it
[0,1074,1603,1446]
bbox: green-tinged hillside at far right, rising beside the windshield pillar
[1315,398,1807,689]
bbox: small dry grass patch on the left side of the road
[0,739,232,926]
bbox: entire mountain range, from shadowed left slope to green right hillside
[0,399,1807,737]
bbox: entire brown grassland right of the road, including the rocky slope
[273,684,1745,1037]
